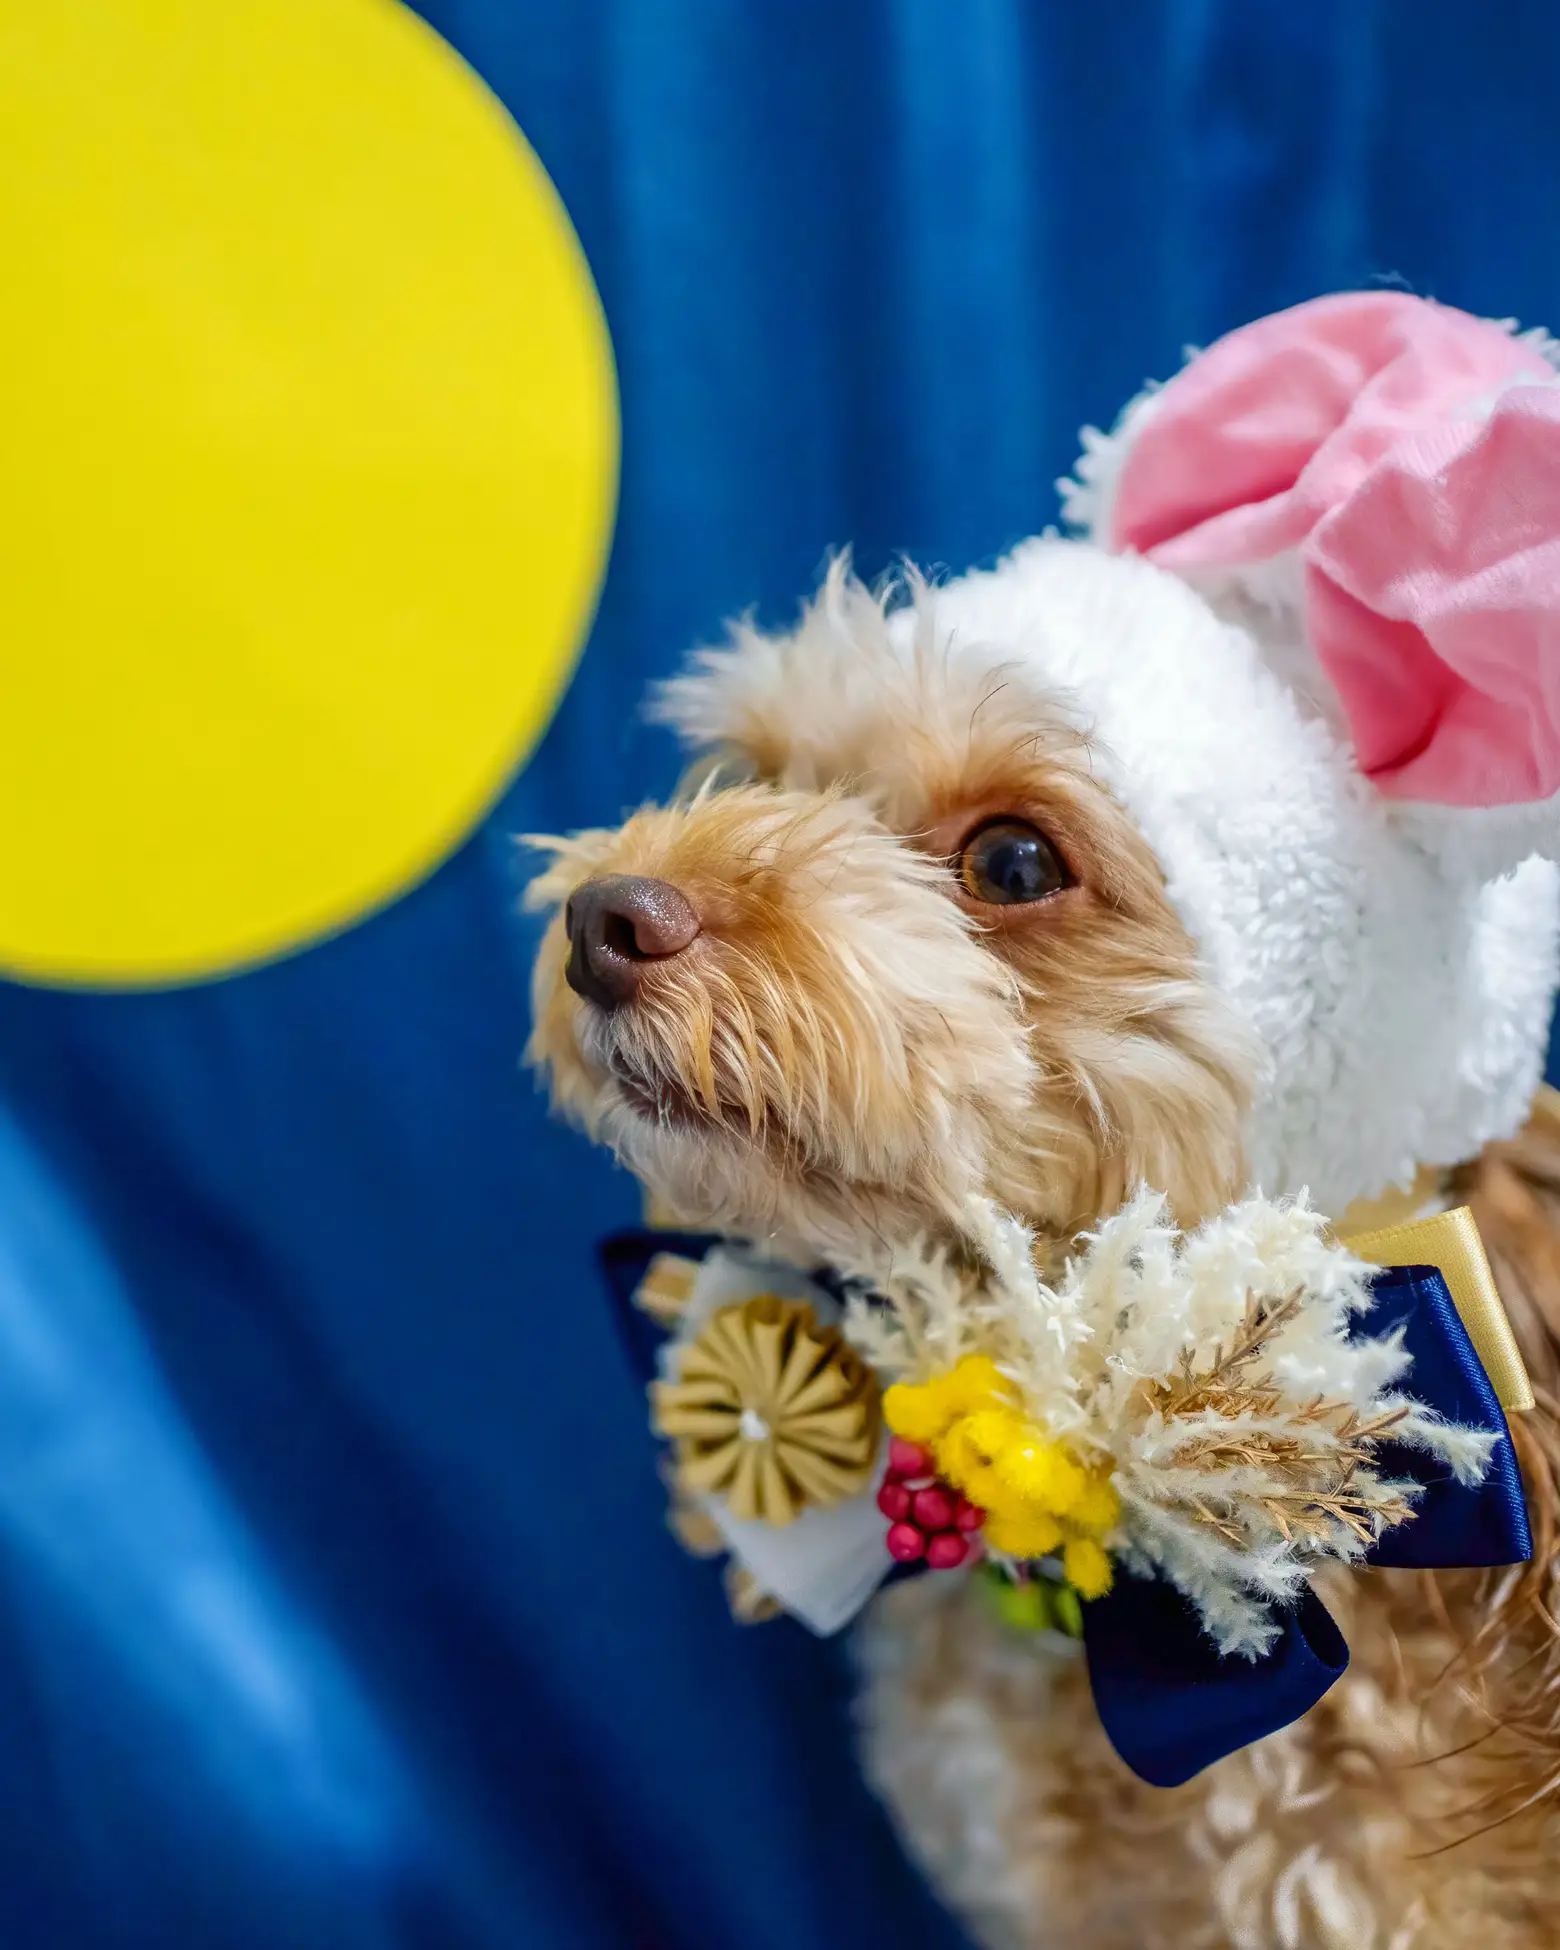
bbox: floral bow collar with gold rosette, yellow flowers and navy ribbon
[603,1193,1533,1786]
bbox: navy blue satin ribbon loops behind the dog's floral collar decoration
[603,1232,1533,1788]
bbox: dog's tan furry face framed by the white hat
[530,571,1256,1256]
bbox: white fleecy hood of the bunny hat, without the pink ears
[907,538,1560,1211]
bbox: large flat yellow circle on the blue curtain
[0,0,616,987]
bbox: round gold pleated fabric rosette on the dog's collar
[651,1293,881,1525]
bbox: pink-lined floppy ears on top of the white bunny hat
[1063,291,1560,878]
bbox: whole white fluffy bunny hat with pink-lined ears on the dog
[908,293,1560,1213]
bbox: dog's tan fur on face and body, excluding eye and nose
[534,544,1560,1950]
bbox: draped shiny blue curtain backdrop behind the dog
[0,0,1560,1950]
